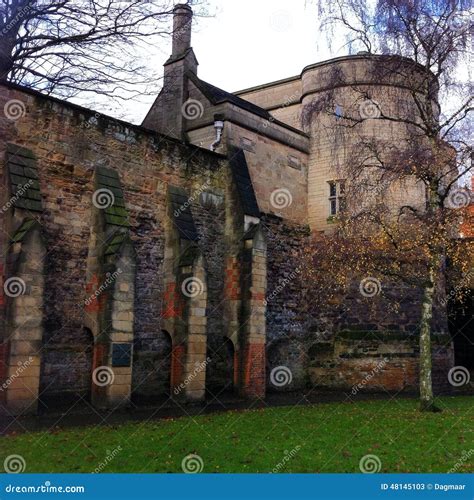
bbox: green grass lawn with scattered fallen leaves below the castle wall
[0,397,474,472]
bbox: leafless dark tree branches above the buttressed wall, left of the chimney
[0,0,204,103]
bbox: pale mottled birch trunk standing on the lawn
[420,258,440,412]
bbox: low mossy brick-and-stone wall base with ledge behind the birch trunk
[308,331,454,396]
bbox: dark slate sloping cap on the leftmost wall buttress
[6,143,43,212]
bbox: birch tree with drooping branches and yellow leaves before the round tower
[303,0,473,411]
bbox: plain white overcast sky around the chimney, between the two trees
[115,0,340,123]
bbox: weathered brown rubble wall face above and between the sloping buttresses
[0,83,241,410]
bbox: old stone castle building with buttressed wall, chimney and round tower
[0,5,460,414]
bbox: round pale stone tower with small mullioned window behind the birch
[301,53,436,231]
